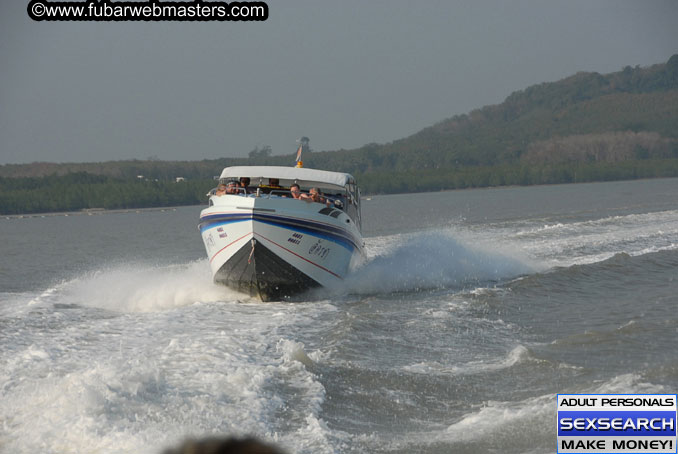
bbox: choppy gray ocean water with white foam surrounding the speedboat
[0,179,678,454]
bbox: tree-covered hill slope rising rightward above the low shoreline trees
[298,55,678,173]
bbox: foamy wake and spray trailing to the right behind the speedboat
[344,210,678,294]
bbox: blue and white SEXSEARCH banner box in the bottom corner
[556,394,678,454]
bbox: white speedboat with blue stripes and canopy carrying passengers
[199,166,364,301]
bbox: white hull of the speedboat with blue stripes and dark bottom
[199,195,363,301]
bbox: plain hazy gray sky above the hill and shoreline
[0,0,678,164]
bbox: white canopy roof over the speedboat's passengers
[220,166,355,189]
